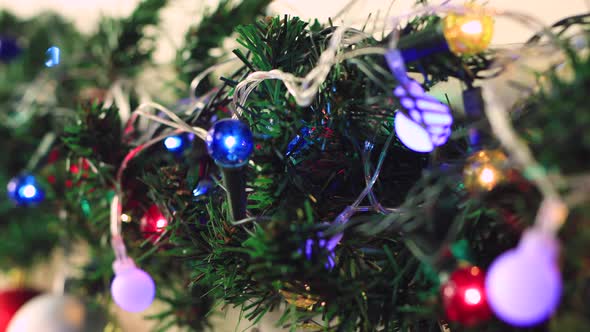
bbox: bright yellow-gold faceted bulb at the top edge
[443,6,494,55]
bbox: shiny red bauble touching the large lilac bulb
[441,266,492,326]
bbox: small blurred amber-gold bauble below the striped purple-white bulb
[463,150,508,193]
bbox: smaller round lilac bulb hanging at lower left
[111,262,156,312]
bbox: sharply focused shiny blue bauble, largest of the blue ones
[207,119,254,168]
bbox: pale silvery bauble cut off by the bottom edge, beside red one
[6,294,107,332]
